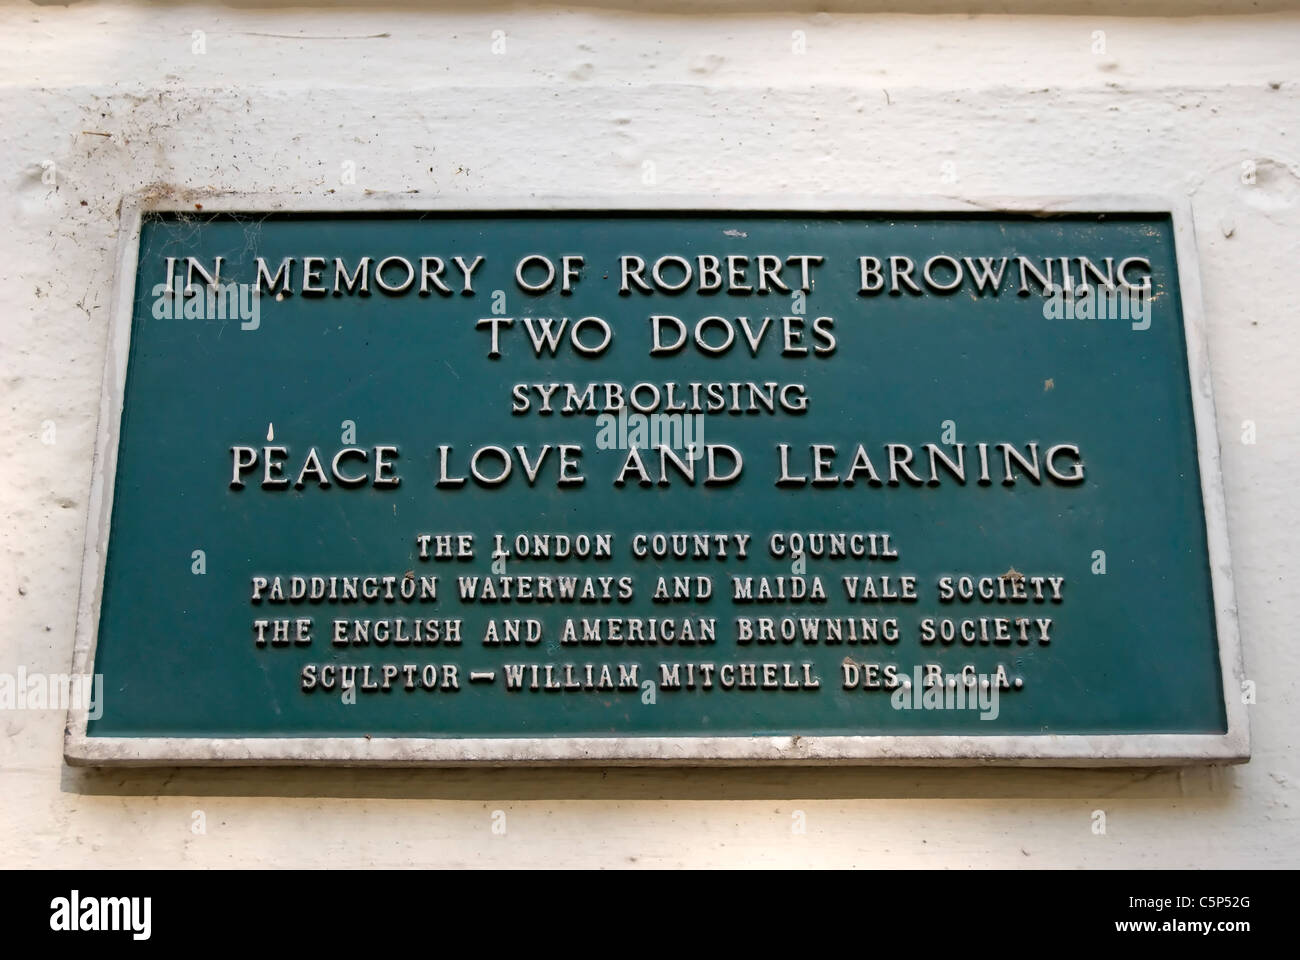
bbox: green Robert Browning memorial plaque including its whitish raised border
[66,198,1248,764]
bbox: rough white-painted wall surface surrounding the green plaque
[0,0,1300,866]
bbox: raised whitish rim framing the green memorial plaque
[64,193,1251,766]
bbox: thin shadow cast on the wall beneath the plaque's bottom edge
[61,765,1238,805]
